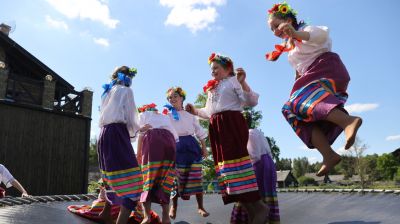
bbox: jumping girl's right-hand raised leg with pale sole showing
[326,108,362,149]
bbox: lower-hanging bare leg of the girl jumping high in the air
[311,126,341,176]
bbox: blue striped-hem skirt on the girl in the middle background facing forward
[176,135,203,200]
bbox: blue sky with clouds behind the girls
[0,0,400,161]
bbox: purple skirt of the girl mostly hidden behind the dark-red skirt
[231,154,280,224]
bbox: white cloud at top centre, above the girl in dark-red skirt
[160,0,226,33]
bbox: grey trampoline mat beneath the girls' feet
[0,192,400,224]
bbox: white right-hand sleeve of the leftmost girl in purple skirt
[124,88,139,137]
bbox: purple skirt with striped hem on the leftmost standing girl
[97,123,143,210]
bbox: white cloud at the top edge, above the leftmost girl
[47,0,119,28]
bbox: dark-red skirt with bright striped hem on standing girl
[209,111,261,204]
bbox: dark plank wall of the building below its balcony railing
[0,102,91,195]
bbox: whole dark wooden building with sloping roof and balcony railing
[0,24,93,195]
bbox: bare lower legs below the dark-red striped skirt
[241,200,269,224]
